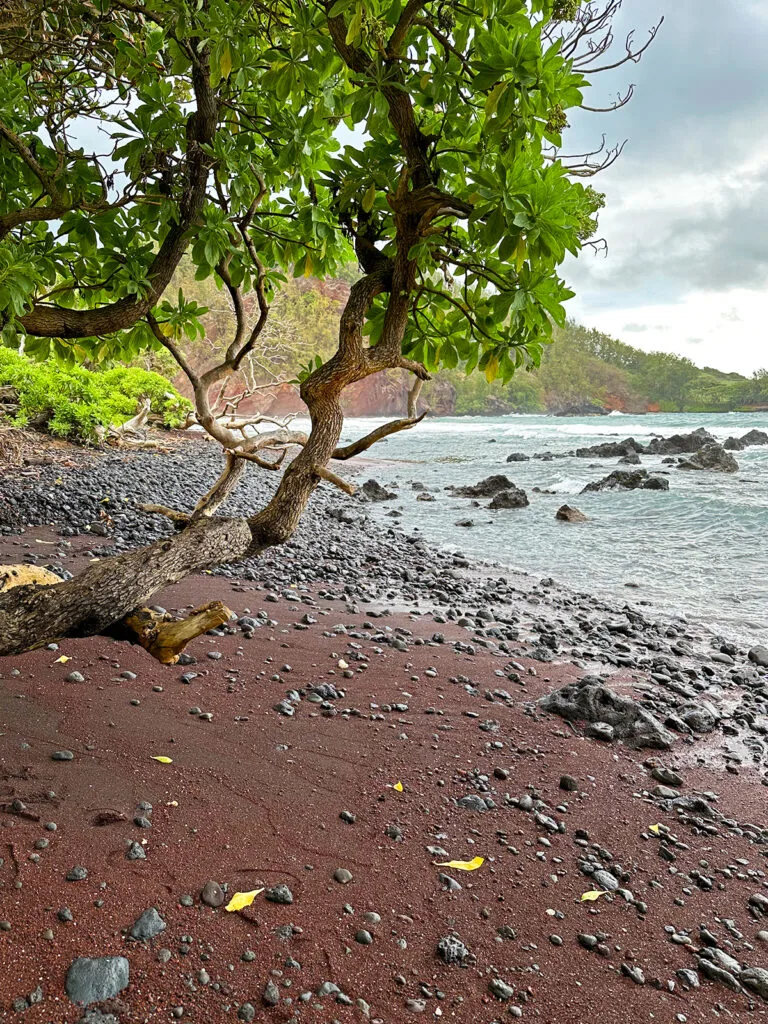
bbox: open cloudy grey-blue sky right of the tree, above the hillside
[564,0,768,374]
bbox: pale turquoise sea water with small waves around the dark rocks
[335,413,768,642]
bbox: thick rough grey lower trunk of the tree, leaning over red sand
[0,517,252,655]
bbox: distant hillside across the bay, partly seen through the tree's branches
[157,268,768,416]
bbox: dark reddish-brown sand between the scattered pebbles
[0,531,768,1024]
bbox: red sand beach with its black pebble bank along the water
[0,441,768,1024]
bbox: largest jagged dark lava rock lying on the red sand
[539,676,675,751]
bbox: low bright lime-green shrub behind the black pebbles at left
[0,348,191,442]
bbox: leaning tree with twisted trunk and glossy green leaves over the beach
[0,0,655,653]
